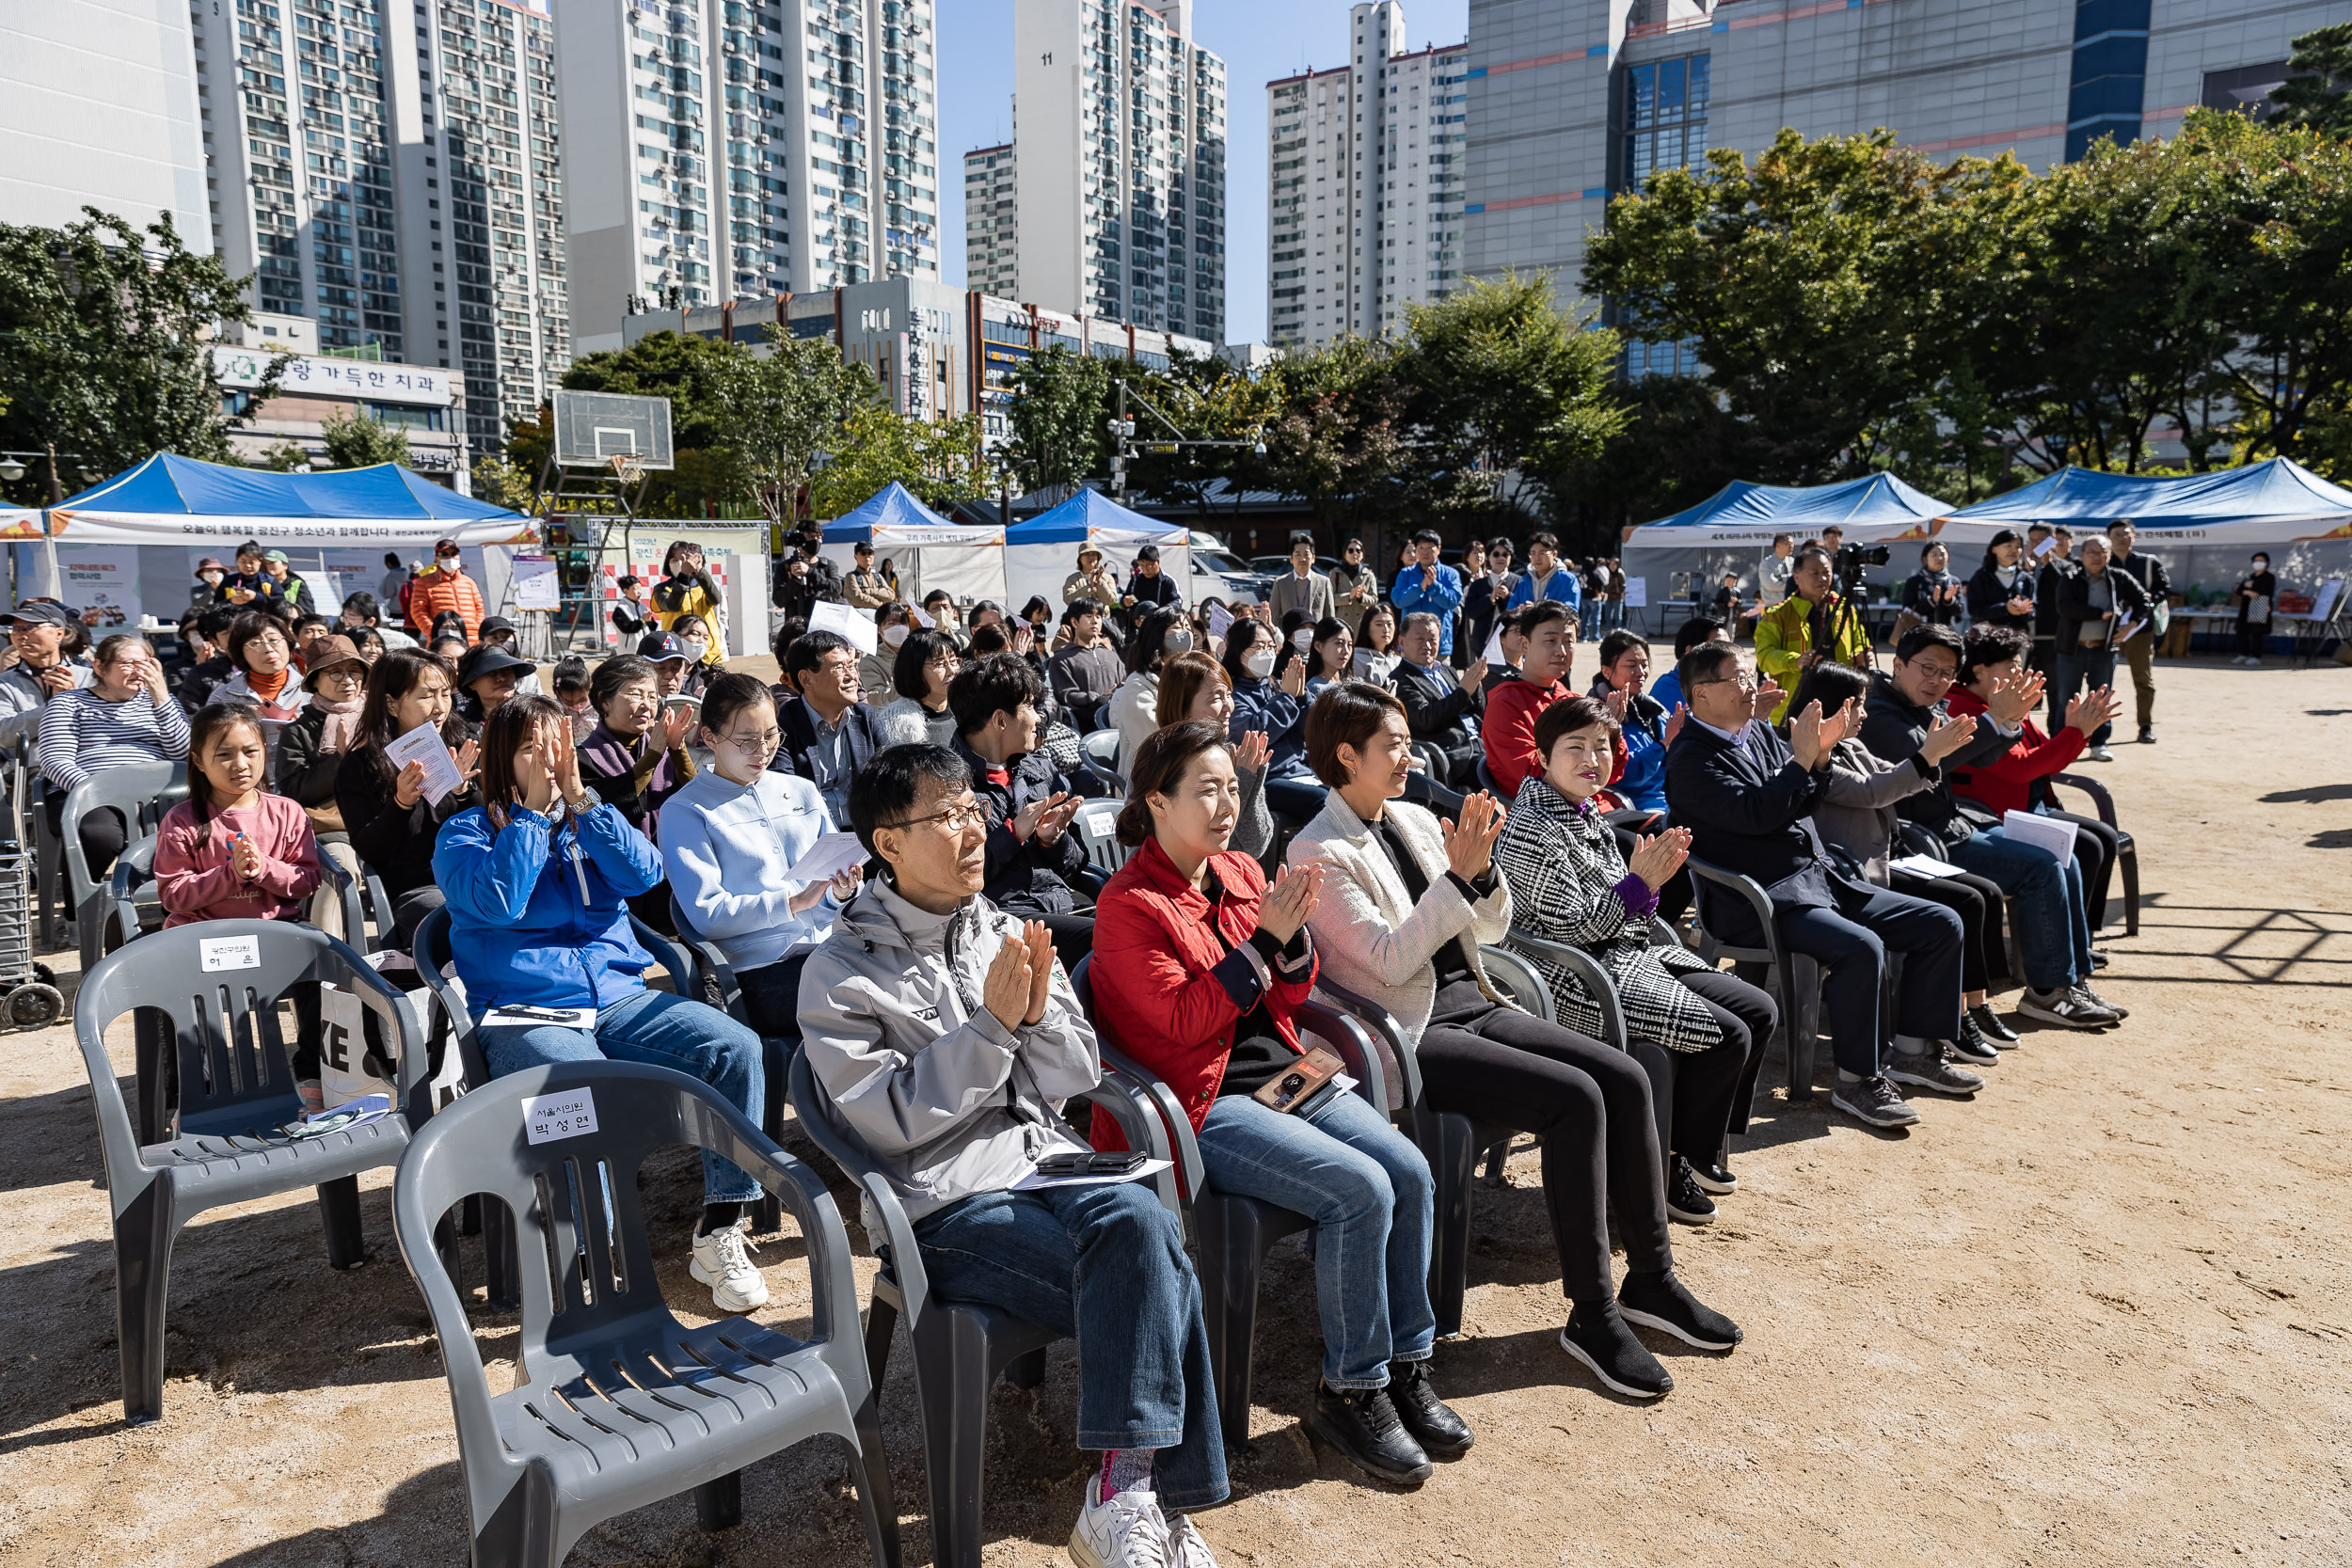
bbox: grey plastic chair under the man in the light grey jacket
[790,1053,1179,1568]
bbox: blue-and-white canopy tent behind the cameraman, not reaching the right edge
[1618,472,1947,637]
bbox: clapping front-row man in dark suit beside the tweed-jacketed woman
[1665,641,1985,1126]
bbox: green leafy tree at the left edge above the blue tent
[0,207,262,499]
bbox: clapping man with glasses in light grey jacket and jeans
[800,745,1226,1568]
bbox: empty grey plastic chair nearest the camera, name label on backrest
[393,1063,898,1568]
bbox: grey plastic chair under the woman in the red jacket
[1071,955,1388,1449]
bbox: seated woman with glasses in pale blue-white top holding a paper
[661,674,859,1039]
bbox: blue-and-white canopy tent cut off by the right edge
[1936,458,2352,653]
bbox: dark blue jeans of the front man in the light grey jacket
[915,1182,1226,1510]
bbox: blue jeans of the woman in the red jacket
[1200,1093,1438,1389]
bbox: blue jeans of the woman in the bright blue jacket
[475,990,765,1204]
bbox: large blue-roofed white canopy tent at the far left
[5,451,539,637]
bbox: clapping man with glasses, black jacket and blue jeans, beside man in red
[1863,626,2117,1049]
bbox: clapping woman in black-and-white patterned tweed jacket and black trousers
[1494,696,1778,1215]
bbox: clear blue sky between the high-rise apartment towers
[934,0,1470,343]
